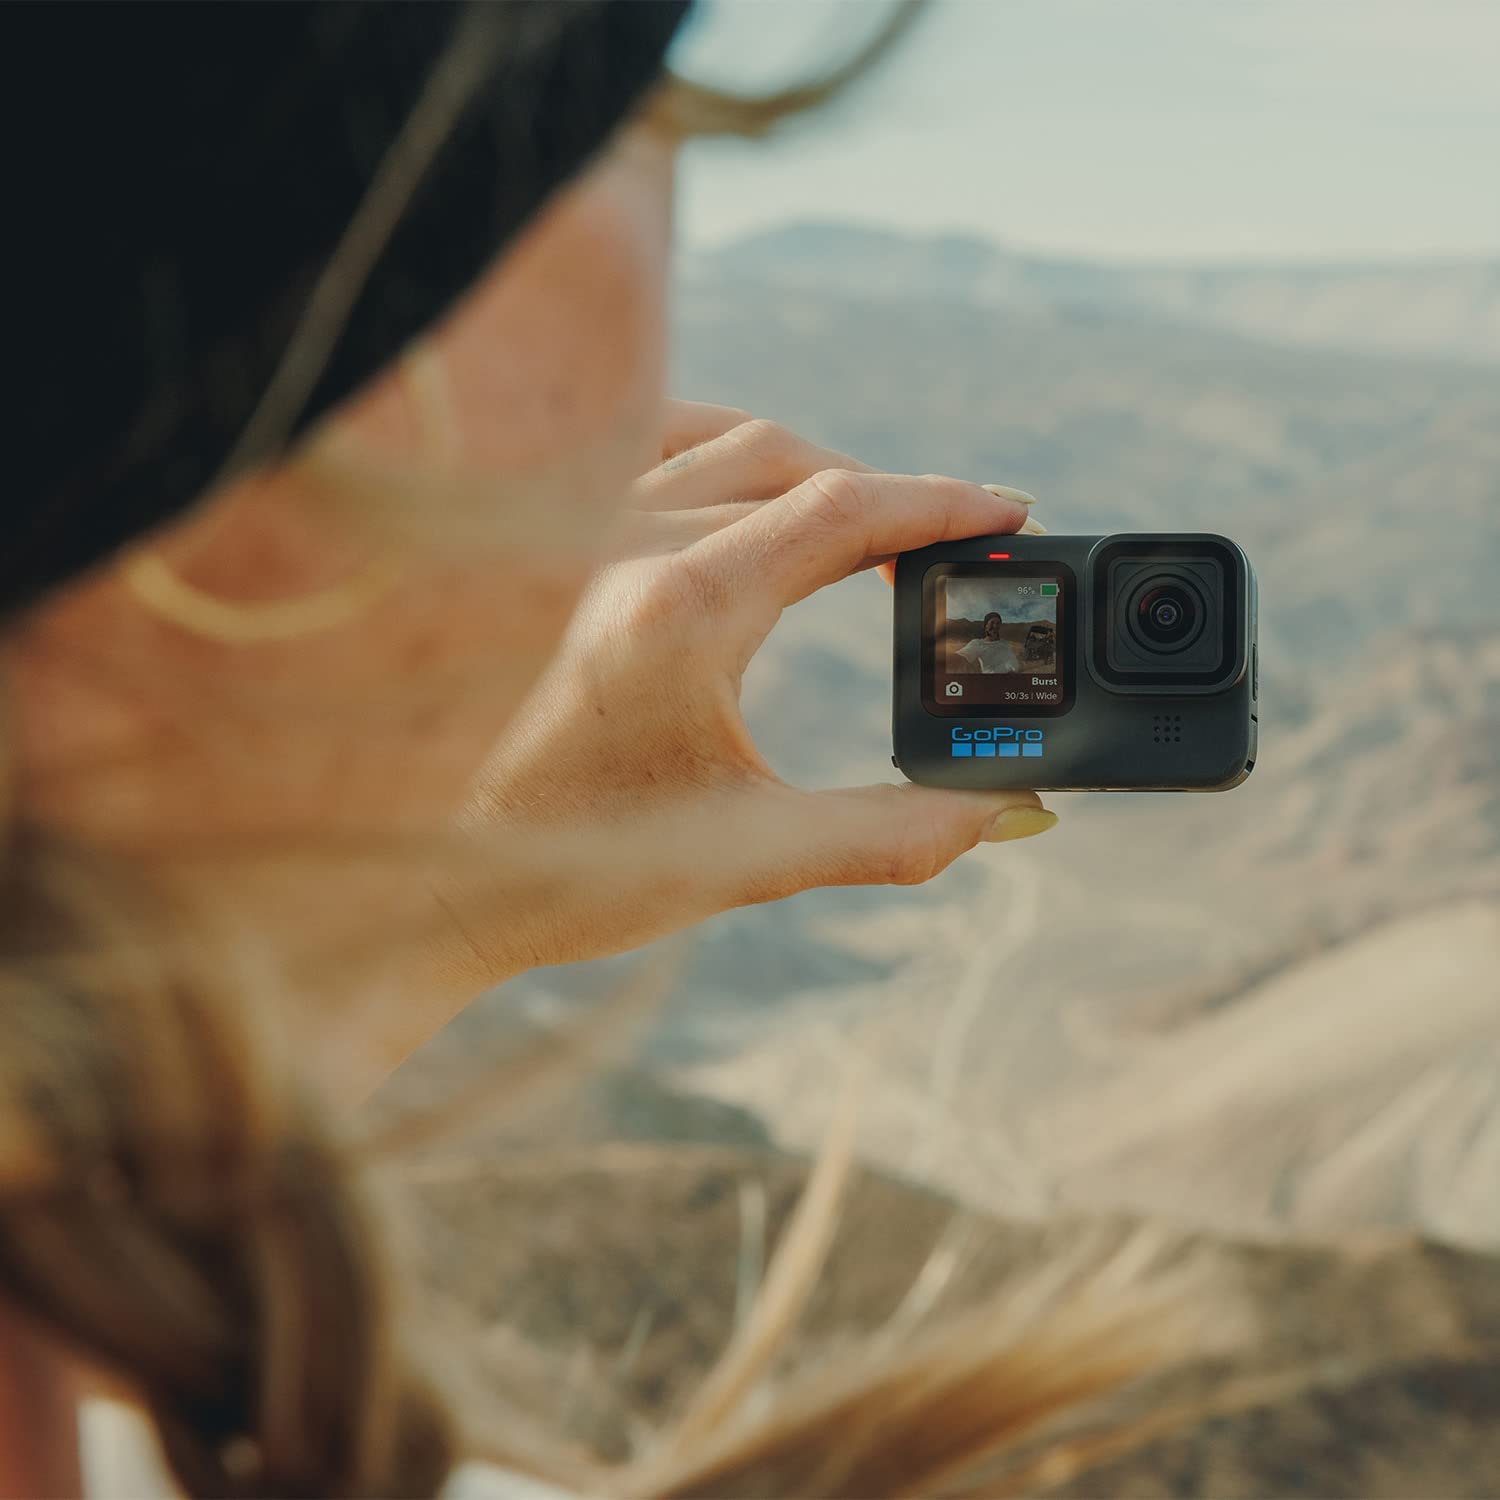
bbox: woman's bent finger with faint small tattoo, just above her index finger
[630,419,870,510]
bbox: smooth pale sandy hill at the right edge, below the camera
[1038,902,1500,1244]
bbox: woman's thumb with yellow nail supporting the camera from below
[738,785,1058,900]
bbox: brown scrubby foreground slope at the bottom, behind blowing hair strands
[411,1146,1500,1500]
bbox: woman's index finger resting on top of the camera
[695,470,1026,609]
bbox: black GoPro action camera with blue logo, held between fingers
[893,533,1260,792]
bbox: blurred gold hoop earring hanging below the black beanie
[120,552,398,647]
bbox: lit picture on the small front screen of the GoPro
[932,575,1064,708]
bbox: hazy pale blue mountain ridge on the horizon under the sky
[690,224,1500,363]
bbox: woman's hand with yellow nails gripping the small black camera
[443,404,1056,989]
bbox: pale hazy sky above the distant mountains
[674,0,1500,258]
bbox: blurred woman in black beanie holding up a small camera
[0,0,1146,1494]
